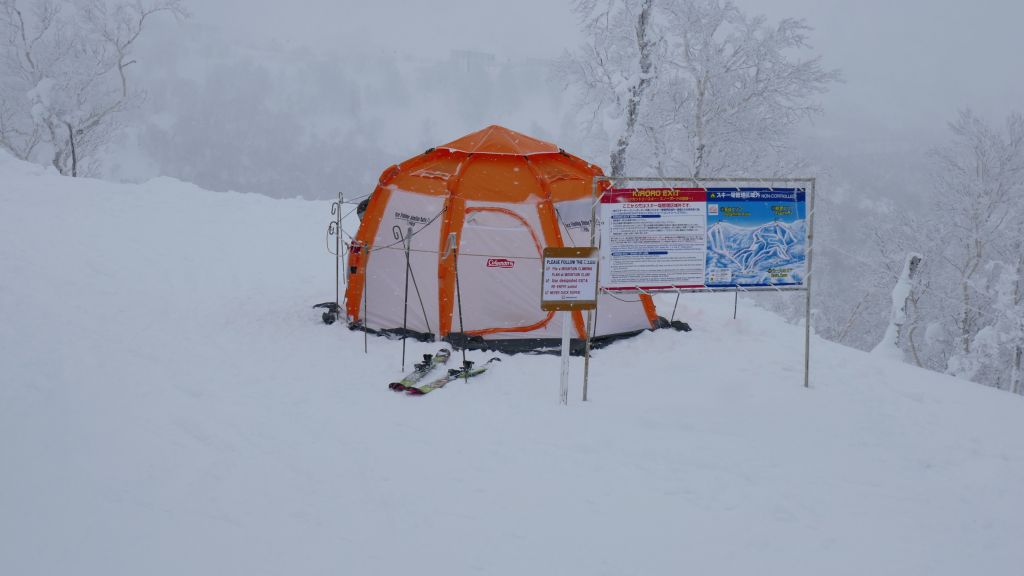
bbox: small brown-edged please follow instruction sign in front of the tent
[541,247,598,311]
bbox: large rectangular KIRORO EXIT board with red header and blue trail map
[601,188,807,291]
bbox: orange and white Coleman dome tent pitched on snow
[345,126,657,352]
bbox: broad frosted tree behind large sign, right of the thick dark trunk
[652,0,839,176]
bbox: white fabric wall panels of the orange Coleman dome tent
[360,190,649,339]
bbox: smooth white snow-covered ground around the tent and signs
[0,155,1024,576]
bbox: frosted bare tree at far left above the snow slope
[0,0,185,176]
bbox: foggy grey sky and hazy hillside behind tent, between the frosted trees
[103,0,1024,198]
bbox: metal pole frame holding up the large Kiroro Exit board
[584,176,817,389]
